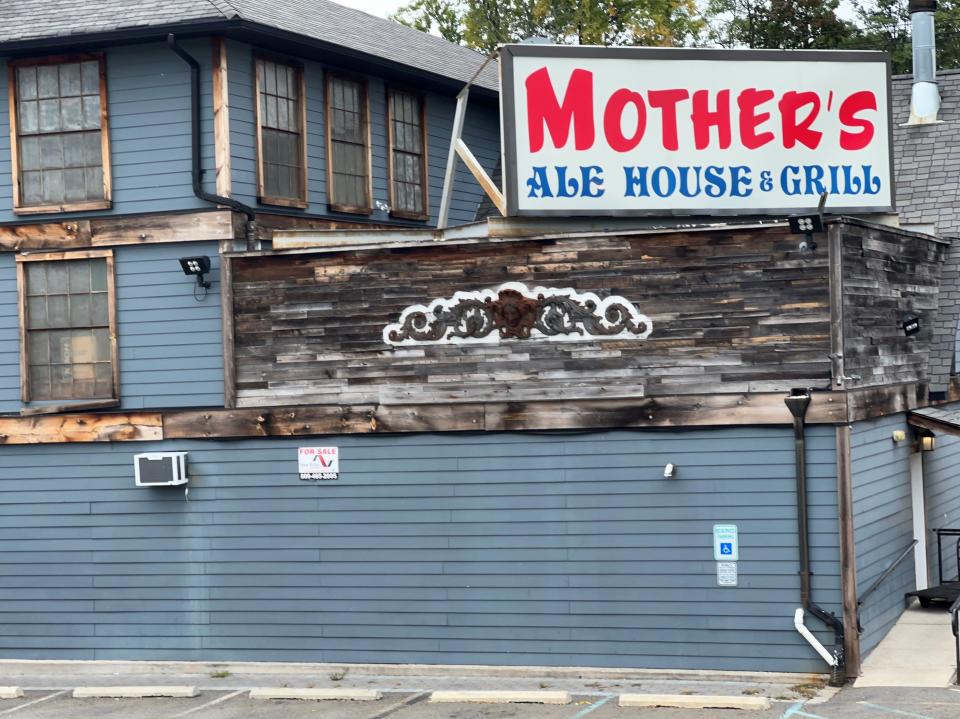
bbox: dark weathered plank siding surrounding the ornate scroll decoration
[234,228,830,405]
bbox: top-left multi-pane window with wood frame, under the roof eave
[9,55,110,213]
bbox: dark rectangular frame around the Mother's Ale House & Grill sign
[500,45,897,217]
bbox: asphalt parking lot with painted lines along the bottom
[0,688,960,719]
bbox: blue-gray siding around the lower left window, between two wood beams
[0,242,223,412]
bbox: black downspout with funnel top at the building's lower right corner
[784,389,847,687]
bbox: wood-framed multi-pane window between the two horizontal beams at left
[17,250,118,402]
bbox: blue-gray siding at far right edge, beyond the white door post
[923,434,960,584]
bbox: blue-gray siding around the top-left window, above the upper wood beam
[0,39,215,222]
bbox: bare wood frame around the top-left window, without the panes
[7,52,113,215]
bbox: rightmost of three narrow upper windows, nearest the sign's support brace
[387,90,429,220]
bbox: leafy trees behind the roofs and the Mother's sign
[394,0,960,73]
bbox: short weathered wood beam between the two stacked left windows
[0,210,234,252]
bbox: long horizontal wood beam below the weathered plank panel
[0,384,925,444]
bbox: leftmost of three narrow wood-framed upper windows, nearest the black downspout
[256,58,307,207]
